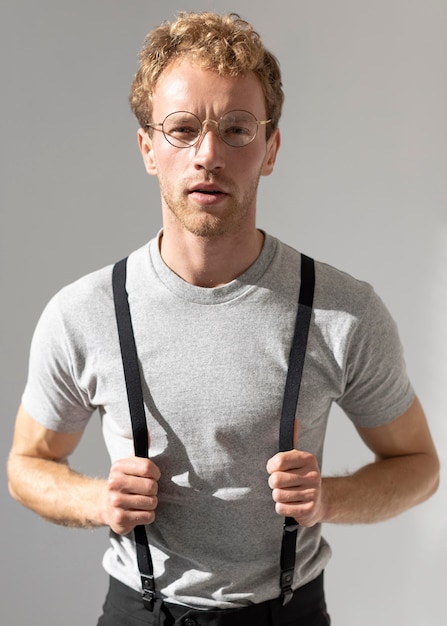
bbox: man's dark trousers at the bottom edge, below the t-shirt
[97,574,331,626]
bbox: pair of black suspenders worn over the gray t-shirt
[112,254,315,610]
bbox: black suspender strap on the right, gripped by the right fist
[279,254,315,604]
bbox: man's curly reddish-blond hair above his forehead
[129,11,284,136]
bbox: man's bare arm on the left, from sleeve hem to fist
[8,407,160,534]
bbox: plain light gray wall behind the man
[0,0,447,626]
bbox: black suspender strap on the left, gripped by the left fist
[112,259,155,611]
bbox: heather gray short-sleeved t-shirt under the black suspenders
[23,235,414,608]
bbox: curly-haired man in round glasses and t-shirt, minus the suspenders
[8,13,439,626]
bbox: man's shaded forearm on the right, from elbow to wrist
[320,453,439,524]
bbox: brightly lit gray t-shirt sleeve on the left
[22,294,95,432]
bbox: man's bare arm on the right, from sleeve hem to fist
[267,400,439,526]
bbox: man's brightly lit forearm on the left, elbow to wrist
[8,455,106,528]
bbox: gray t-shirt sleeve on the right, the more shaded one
[338,288,415,427]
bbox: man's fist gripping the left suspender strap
[105,457,160,535]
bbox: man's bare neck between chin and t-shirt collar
[160,223,264,287]
